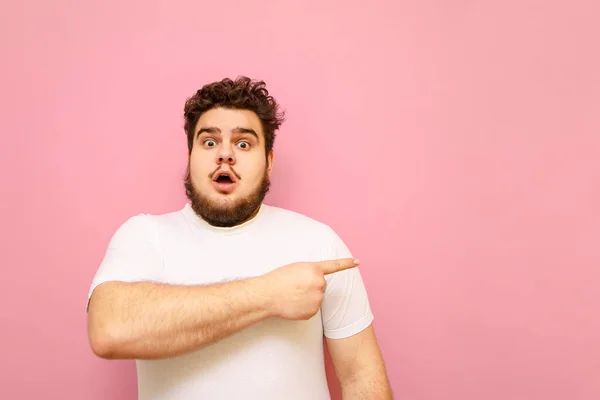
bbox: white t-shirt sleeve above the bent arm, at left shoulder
[86,214,163,310]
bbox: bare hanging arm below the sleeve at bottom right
[326,325,392,400]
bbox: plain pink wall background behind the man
[0,0,600,400]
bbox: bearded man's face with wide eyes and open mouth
[186,108,273,226]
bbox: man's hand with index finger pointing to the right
[260,258,360,320]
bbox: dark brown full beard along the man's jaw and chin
[184,163,271,228]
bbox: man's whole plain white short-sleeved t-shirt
[88,204,373,400]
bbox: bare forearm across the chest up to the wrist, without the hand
[88,278,270,359]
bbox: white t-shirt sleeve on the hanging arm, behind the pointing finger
[321,230,373,339]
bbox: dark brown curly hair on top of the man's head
[183,76,284,156]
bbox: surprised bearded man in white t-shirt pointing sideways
[88,77,391,400]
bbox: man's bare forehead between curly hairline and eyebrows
[195,107,264,137]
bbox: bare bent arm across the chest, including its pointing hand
[88,259,358,359]
